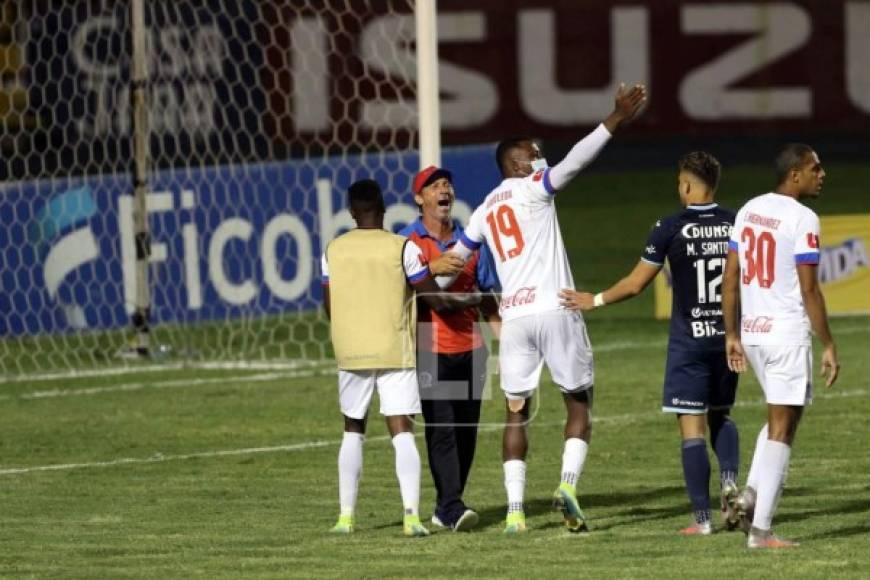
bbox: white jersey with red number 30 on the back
[729,193,820,345]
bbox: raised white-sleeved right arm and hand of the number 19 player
[549,84,646,190]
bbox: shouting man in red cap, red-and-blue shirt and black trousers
[399,165,500,531]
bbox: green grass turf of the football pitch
[0,161,870,578]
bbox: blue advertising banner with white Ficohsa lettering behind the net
[0,146,499,336]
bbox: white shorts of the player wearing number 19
[498,310,595,400]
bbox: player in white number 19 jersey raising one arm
[438,85,646,534]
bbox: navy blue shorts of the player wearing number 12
[662,349,737,415]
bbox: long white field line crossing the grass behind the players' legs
[0,389,870,477]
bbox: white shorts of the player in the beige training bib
[338,369,420,419]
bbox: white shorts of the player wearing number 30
[743,345,813,406]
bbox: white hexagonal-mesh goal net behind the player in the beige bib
[0,0,419,378]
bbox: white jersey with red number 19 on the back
[461,169,574,320]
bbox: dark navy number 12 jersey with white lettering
[641,203,735,350]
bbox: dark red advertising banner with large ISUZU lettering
[265,0,870,144]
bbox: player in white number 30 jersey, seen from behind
[722,144,840,548]
